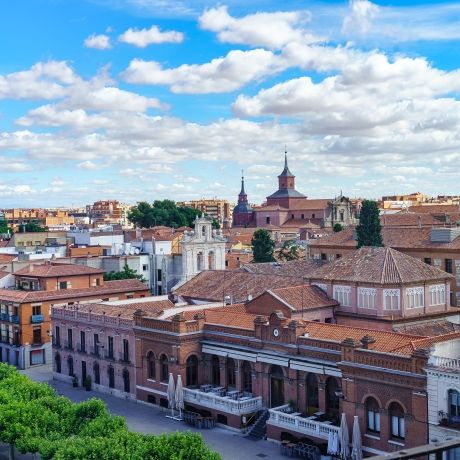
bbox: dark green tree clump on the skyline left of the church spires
[128,200,200,228]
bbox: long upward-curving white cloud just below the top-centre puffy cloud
[122,49,284,94]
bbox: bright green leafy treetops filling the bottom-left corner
[0,363,220,460]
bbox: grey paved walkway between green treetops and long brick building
[18,366,286,460]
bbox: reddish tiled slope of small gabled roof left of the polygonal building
[268,285,338,310]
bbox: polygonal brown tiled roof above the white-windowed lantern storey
[312,247,452,284]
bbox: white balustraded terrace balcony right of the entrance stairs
[267,404,339,440]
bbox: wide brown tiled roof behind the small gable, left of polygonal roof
[174,269,302,303]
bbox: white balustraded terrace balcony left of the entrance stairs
[184,388,262,415]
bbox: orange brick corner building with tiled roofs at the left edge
[0,262,149,369]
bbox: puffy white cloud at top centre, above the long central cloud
[199,6,321,49]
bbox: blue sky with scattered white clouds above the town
[0,0,460,208]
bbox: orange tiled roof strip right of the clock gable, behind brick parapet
[305,322,420,354]
